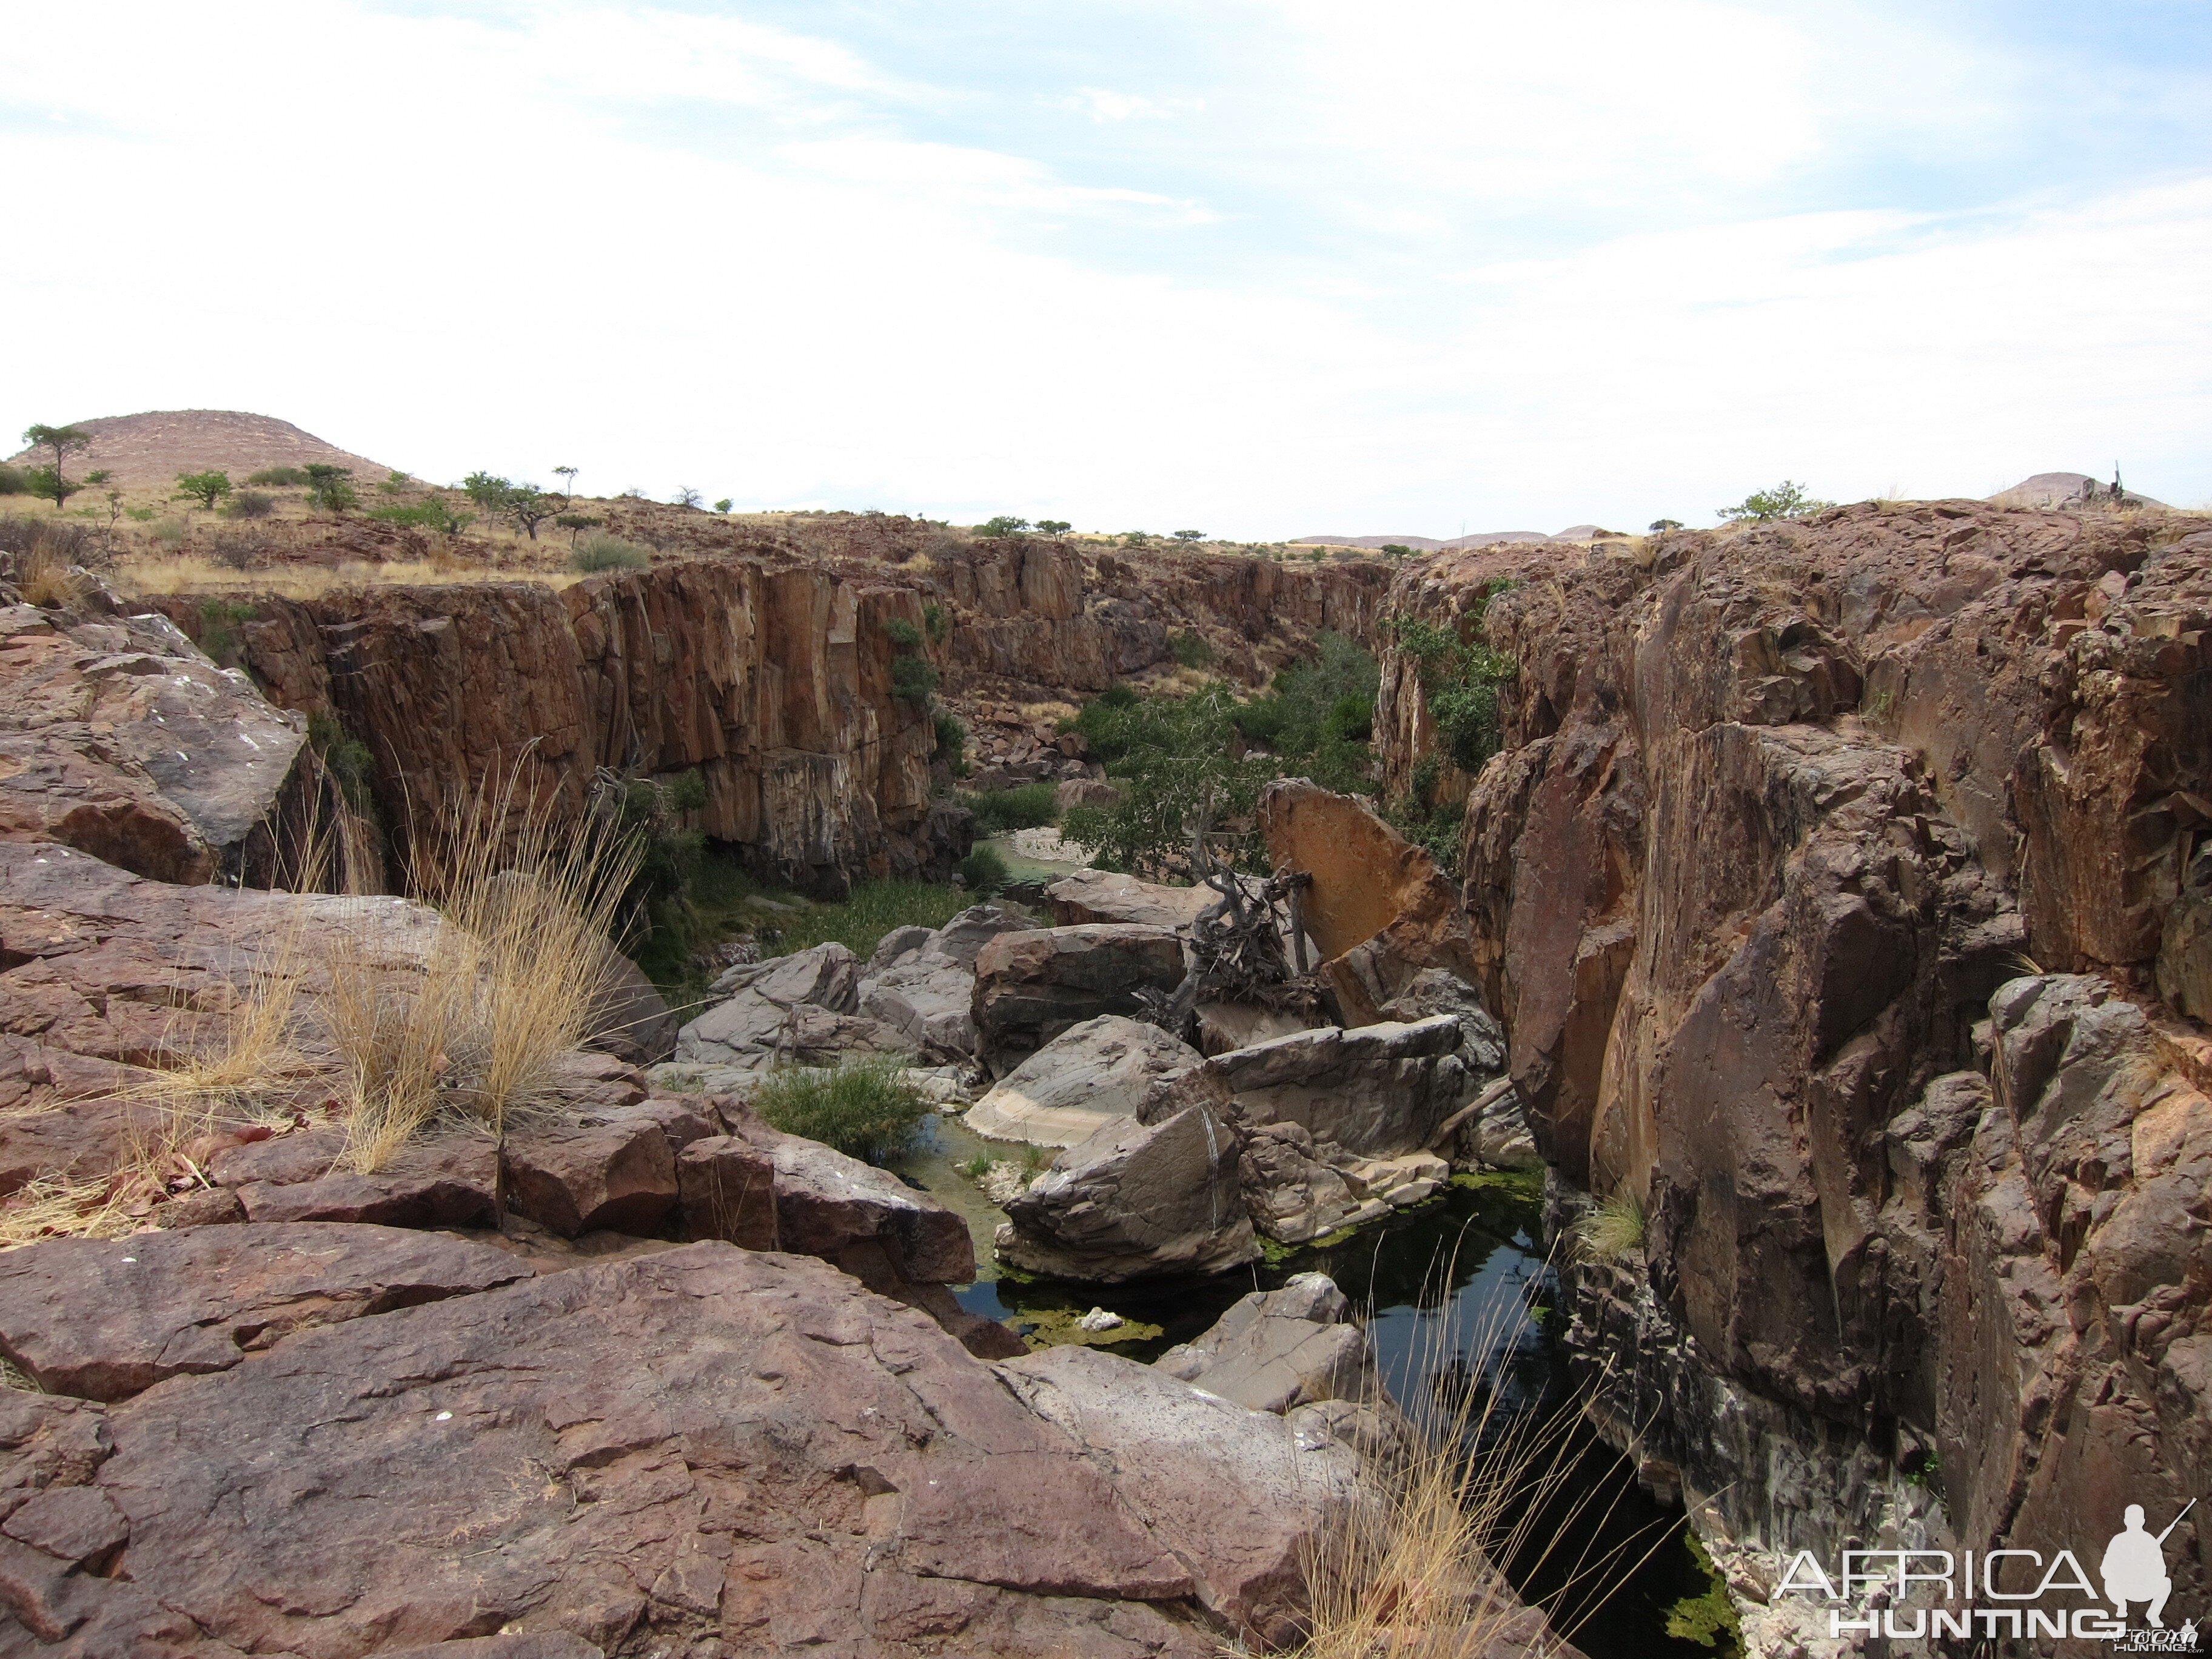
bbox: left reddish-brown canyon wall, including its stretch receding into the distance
[190,540,1382,891]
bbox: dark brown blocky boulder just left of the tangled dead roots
[976,922,1184,1078]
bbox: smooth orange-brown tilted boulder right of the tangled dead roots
[1259,779,1475,1024]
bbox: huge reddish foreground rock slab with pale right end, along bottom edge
[25,1243,1342,1659]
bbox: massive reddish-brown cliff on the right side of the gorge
[1382,502,2212,1627]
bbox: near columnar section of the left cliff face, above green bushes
[222,560,949,889]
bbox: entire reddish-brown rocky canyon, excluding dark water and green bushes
[0,486,2212,1659]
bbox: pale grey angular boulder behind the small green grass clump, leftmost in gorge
[677,940,916,1071]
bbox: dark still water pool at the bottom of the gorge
[958,1177,1734,1659]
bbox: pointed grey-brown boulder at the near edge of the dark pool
[997,1099,1259,1285]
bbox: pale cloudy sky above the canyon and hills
[0,0,2212,540]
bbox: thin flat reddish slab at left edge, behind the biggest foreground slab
[0,1221,529,1400]
